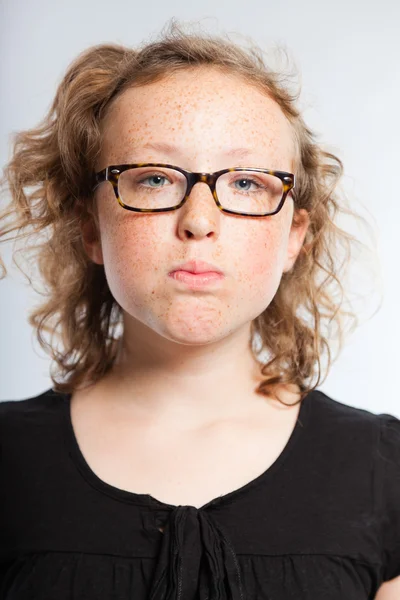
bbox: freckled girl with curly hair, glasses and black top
[0,18,400,600]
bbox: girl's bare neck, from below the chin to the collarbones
[91,327,274,426]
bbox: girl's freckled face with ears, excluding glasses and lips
[82,69,307,344]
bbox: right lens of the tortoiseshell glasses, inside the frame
[216,171,284,215]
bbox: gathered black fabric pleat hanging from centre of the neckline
[149,506,245,600]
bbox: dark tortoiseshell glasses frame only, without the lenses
[92,163,295,218]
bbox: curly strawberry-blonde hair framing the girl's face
[0,19,382,401]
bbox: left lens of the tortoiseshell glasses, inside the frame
[118,167,187,210]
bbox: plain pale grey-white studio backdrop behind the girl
[0,0,400,417]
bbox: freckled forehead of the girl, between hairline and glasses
[101,68,294,169]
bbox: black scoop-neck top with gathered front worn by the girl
[0,389,400,600]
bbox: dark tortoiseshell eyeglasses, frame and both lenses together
[92,163,295,217]
